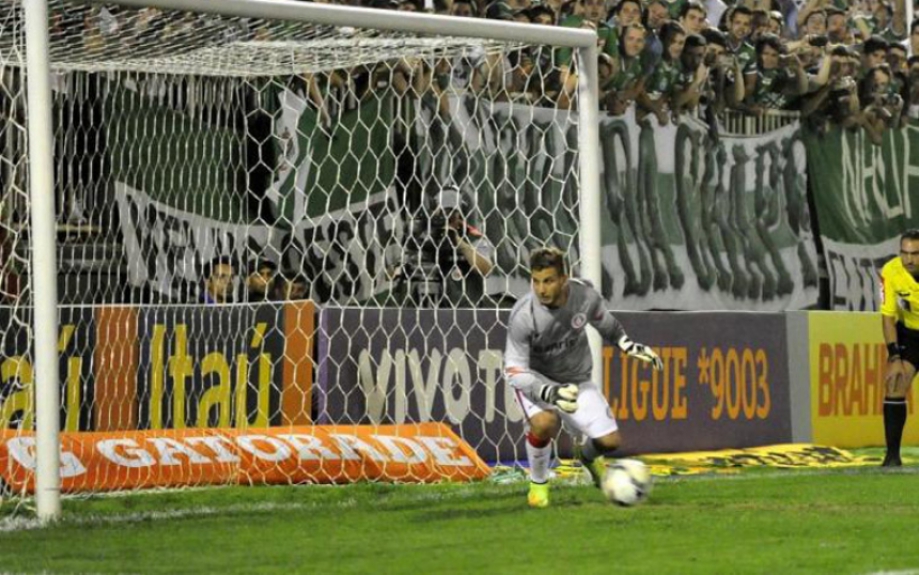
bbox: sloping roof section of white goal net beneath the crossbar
[0,0,505,78]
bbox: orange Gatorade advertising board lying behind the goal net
[0,423,490,493]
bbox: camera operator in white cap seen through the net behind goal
[395,185,495,307]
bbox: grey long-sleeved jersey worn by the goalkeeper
[504,280,625,395]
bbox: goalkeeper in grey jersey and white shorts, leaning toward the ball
[504,248,663,507]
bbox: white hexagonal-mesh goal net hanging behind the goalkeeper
[0,0,596,510]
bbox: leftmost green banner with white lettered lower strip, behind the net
[102,75,282,303]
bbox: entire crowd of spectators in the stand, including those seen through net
[70,0,919,142]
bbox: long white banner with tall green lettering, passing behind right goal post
[416,101,818,311]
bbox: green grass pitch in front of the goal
[0,467,919,575]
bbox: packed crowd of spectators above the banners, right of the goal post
[446,0,919,143]
